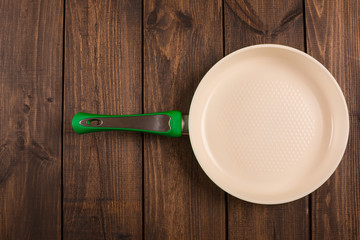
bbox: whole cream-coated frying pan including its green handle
[72,44,349,204]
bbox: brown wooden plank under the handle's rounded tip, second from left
[63,0,142,239]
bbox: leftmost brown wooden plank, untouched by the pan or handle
[0,0,64,239]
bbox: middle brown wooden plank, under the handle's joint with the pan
[143,0,225,239]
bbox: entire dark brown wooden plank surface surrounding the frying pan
[0,0,360,240]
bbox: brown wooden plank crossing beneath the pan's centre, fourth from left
[224,0,310,240]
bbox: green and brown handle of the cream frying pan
[72,111,183,137]
